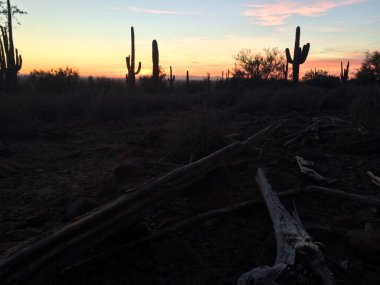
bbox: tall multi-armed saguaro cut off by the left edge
[0,0,22,93]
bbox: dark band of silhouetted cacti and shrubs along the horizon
[0,1,380,138]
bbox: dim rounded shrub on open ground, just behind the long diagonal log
[168,111,225,162]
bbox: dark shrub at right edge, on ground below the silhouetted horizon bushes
[347,86,380,130]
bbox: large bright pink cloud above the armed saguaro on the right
[244,0,366,26]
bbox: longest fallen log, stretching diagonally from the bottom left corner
[0,120,284,285]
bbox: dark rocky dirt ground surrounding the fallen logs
[0,107,380,285]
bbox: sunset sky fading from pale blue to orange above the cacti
[11,0,380,78]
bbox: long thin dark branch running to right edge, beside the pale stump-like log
[305,185,380,206]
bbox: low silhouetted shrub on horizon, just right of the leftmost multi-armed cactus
[29,67,79,93]
